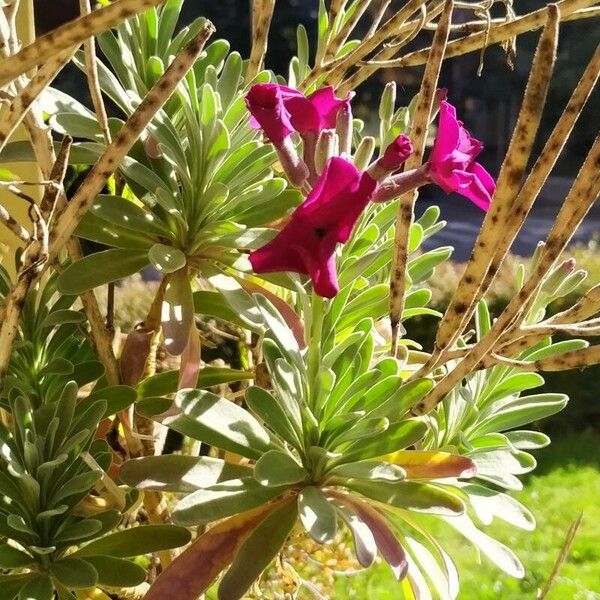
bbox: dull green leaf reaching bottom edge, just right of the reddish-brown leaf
[218,503,298,600]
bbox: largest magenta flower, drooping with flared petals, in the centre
[250,156,377,298]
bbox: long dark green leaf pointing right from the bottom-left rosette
[71,525,191,558]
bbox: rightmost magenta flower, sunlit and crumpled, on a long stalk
[427,100,496,211]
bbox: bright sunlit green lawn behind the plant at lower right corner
[335,433,600,600]
